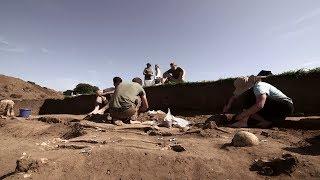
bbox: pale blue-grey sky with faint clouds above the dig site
[0,0,320,91]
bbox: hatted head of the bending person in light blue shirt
[233,76,264,96]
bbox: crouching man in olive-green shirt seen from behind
[109,78,149,125]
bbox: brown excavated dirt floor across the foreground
[0,115,320,179]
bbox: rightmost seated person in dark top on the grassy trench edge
[162,62,185,83]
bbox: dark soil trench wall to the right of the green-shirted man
[146,73,320,115]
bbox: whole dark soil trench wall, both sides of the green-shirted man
[15,73,320,115]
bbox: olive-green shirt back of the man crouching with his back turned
[110,82,145,109]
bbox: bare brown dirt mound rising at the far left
[0,75,63,99]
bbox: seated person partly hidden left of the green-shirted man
[89,77,122,115]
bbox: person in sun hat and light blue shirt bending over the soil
[223,76,294,128]
